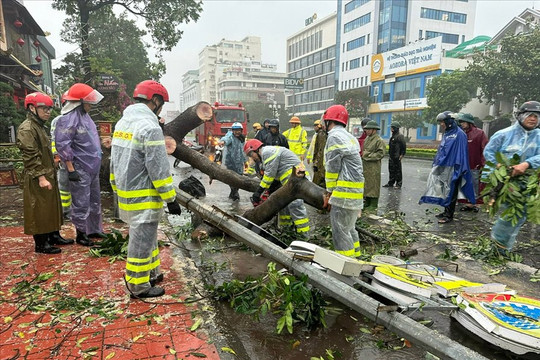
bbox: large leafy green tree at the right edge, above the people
[466,26,540,105]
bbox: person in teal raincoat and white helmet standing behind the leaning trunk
[219,122,246,201]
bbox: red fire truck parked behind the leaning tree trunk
[195,102,249,147]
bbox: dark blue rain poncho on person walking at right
[418,122,476,207]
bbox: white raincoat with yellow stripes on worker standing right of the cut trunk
[324,125,364,210]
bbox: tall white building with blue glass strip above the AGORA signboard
[336,0,476,90]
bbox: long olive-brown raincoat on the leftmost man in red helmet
[17,113,62,235]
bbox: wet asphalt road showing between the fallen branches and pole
[167,153,540,360]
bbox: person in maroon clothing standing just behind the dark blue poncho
[457,113,487,212]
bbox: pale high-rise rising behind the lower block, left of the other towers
[199,36,261,103]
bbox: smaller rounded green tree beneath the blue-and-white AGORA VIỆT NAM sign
[422,71,476,123]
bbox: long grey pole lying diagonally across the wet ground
[176,188,487,360]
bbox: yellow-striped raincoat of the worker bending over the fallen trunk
[259,146,309,233]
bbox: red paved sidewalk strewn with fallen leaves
[0,224,219,360]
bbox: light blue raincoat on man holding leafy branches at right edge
[482,121,540,250]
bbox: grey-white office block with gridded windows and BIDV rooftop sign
[286,13,336,119]
